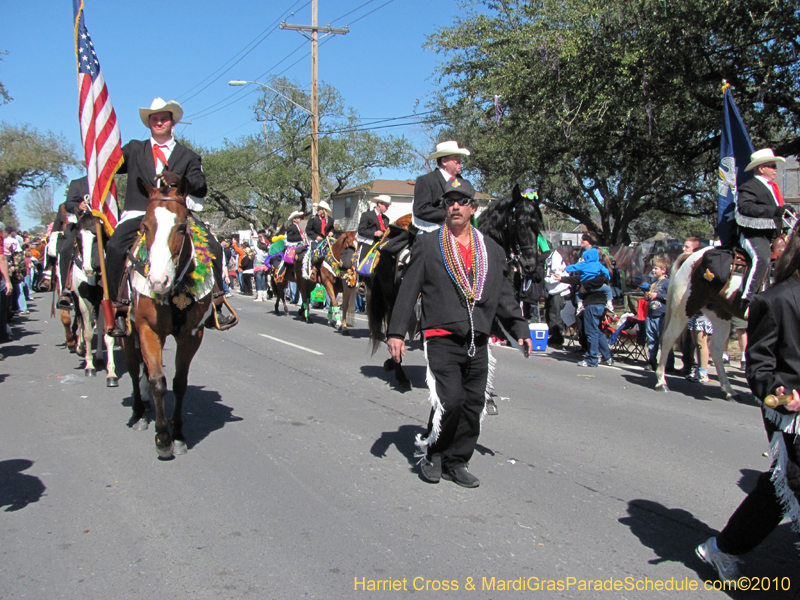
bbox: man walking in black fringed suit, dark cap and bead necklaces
[387,181,532,488]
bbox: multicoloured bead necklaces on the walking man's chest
[439,223,488,358]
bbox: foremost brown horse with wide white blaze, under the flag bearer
[123,179,214,459]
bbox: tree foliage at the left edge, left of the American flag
[0,123,79,208]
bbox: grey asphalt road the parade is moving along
[0,296,800,600]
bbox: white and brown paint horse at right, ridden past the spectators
[655,219,796,401]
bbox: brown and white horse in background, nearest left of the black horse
[294,231,356,333]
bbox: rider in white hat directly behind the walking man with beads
[411,140,469,233]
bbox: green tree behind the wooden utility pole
[198,78,411,227]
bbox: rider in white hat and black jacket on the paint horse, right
[736,148,786,311]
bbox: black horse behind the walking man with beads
[367,185,542,386]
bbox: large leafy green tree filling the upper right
[429,0,800,244]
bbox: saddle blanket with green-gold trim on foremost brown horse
[131,218,214,303]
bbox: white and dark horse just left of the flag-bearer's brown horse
[71,212,119,387]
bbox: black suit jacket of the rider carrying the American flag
[117,139,208,210]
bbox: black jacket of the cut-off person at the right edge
[747,276,800,414]
